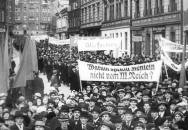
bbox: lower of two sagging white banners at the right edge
[161,51,181,72]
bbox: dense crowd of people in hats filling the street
[0,40,188,130]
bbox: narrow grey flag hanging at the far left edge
[0,29,9,93]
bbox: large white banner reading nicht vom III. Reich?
[78,61,162,82]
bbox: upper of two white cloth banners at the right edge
[159,37,188,53]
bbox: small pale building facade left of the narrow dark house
[56,8,69,40]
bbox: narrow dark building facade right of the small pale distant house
[68,0,81,36]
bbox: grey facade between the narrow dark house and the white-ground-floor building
[80,0,103,36]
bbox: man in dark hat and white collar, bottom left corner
[10,111,27,130]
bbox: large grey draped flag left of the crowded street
[14,37,38,88]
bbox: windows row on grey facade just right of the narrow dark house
[81,3,102,23]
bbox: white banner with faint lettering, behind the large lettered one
[77,37,121,51]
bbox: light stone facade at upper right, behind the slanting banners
[131,0,181,56]
